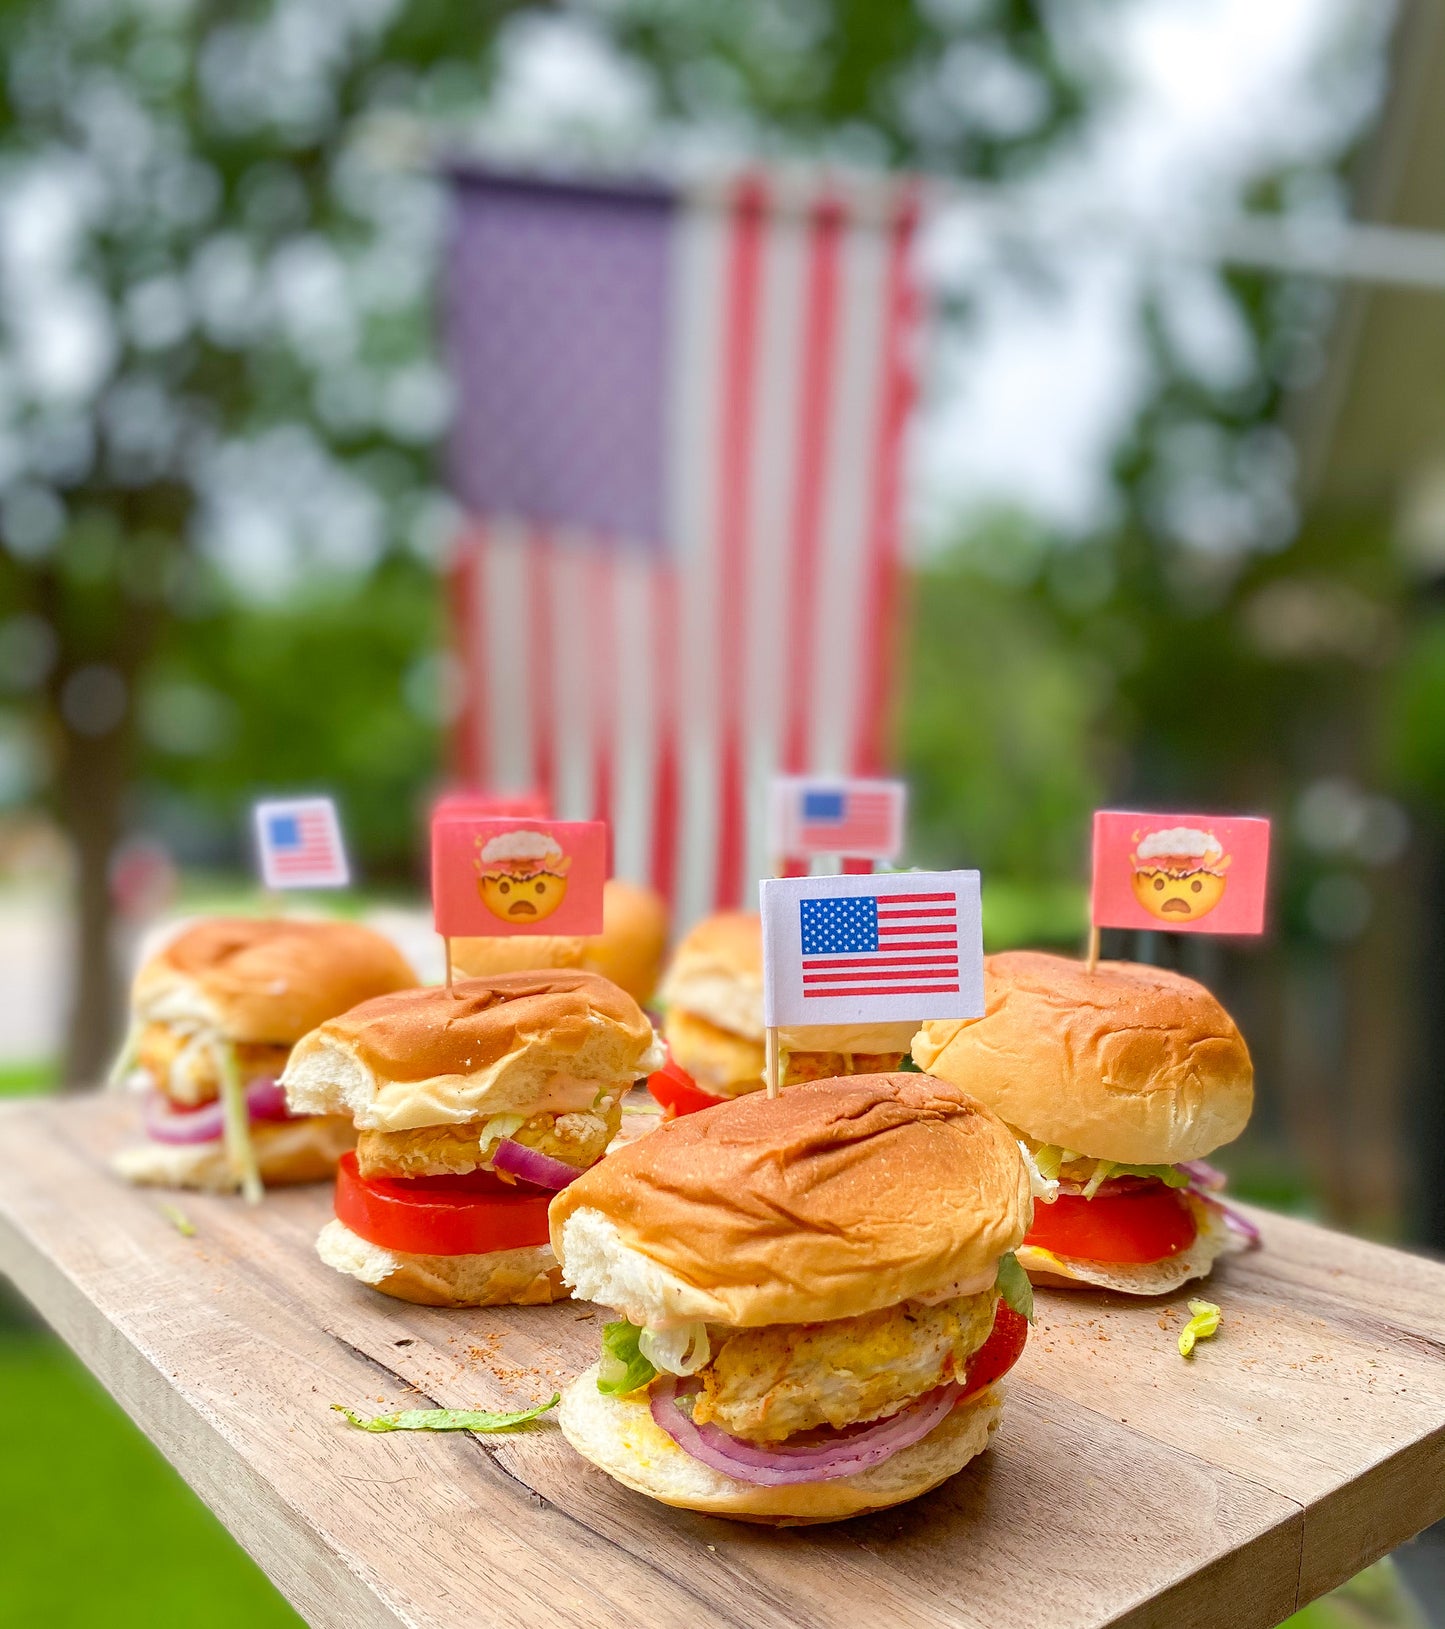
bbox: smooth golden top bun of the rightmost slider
[914,950,1254,1165]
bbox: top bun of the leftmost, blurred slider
[130,917,417,1044]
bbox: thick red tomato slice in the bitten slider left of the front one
[336,1153,552,1256]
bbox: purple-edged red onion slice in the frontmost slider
[650,1377,963,1487]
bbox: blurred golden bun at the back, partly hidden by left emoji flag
[451,876,668,1002]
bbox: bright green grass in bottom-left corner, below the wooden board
[0,1323,301,1629]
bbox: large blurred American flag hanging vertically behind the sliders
[446,171,920,922]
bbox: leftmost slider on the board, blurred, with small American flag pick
[114,917,417,1199]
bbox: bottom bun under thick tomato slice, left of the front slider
[316,1222,567,1306]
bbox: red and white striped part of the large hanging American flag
[453,171,919,924]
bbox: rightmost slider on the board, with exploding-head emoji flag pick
[912,951,1258,1295]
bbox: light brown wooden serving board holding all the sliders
[0,1100,1445,1629]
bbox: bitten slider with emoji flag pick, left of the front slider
[282,969,661,1306]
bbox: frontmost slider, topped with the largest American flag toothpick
[551,1074,1031,1525]
